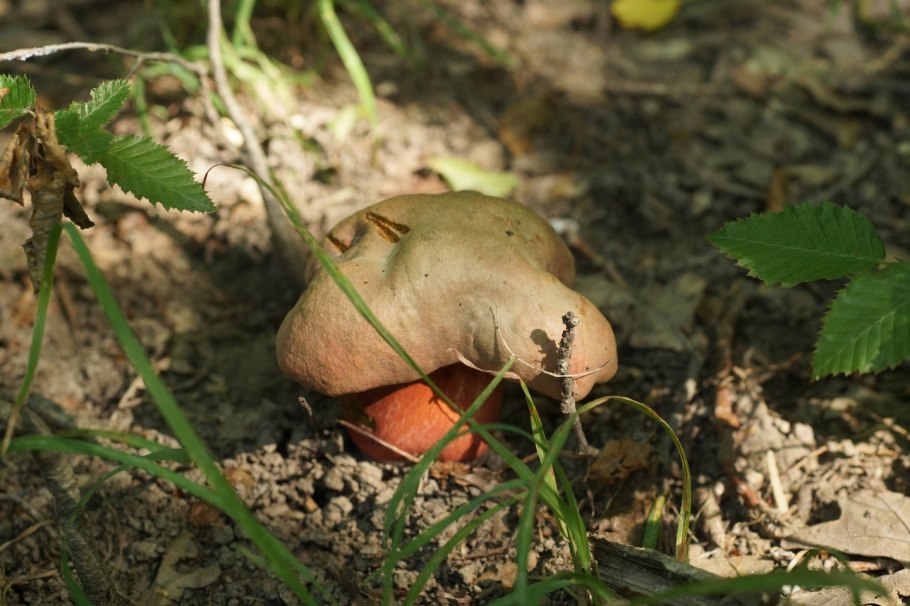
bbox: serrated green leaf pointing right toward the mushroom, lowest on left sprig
[98,136,215,212]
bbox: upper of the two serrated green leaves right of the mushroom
[708,202,885,286]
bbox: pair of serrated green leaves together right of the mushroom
[708,202,910,379]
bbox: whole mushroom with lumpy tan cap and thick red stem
[277,192,617,460]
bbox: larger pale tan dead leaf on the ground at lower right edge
[783,490,910,566]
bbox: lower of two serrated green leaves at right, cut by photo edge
[812,262,910,379]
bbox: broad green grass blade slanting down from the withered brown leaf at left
[58,224,329,606]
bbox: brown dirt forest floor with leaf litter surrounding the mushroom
[0,0,910,605]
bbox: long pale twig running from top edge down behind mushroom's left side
[206,0,309,288]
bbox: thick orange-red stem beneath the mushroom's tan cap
[341,364,502,461]
